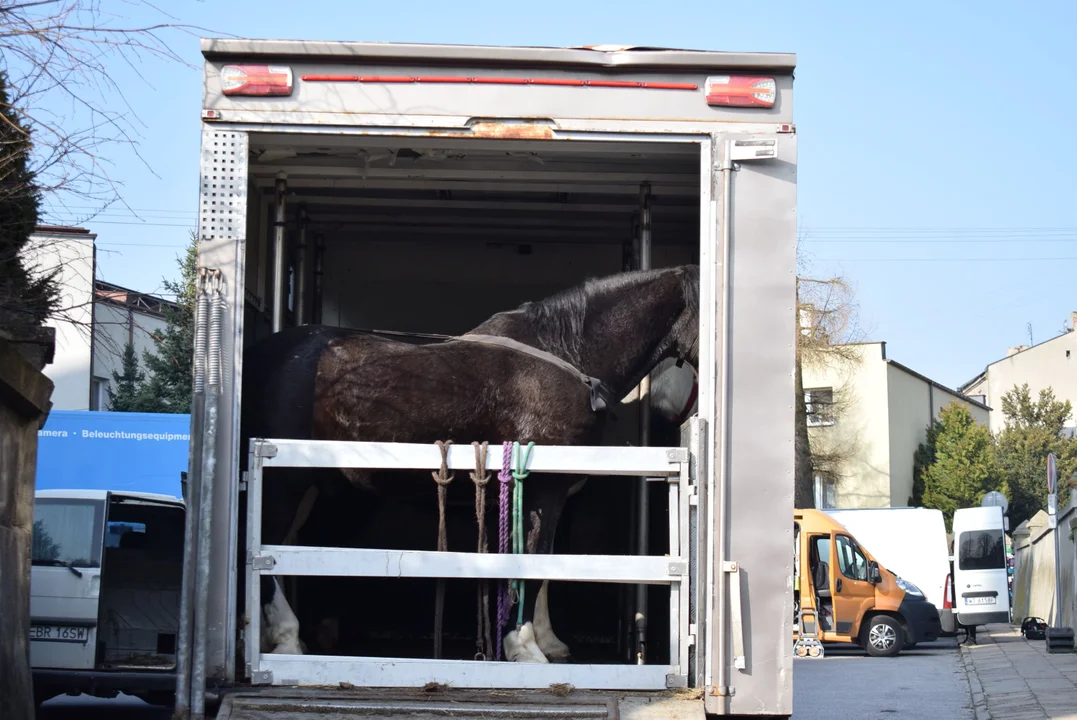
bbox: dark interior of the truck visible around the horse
[238,136,700,664]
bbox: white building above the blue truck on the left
[26,225,174,410]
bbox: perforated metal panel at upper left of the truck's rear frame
[198,125,248,242]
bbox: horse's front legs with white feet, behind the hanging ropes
[504,476,578,663]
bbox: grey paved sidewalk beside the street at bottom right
[961,625,1077,720]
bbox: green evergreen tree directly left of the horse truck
[142,232,198,412]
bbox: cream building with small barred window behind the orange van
[803,342,991,508]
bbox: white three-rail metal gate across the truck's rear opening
[243,439,694,690]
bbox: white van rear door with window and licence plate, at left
[30,497,106,669]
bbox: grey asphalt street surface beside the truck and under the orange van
[38,640,974,720]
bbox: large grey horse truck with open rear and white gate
[177,39,797,719]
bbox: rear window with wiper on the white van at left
[31,497,104,567]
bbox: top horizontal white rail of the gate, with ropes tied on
[251,439,688,477]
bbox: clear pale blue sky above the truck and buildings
[42,0,1077,385]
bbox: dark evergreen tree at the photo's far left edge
[0,72,59,337]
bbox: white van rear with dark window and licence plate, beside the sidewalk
[953,507,1010,626]
